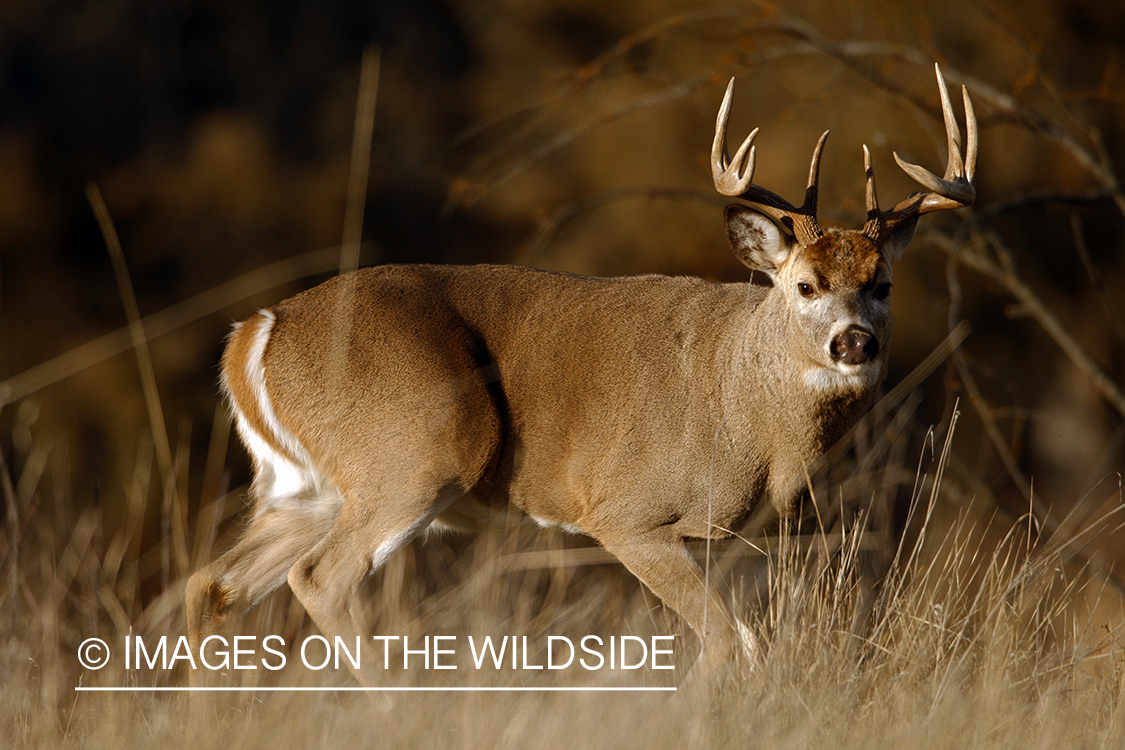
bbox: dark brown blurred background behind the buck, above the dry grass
[0,0,1125,638]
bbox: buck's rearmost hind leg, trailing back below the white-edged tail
[187,505,335,685]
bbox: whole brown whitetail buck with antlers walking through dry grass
[188,71,977,683]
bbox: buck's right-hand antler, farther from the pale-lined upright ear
[863,64,977,245]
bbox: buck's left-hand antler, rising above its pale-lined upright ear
[711,79,832,245]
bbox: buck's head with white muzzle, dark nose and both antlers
[711,65,977,389]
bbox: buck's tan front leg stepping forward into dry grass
[597,530,737,685]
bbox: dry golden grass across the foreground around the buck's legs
[0,411,1125,748]
